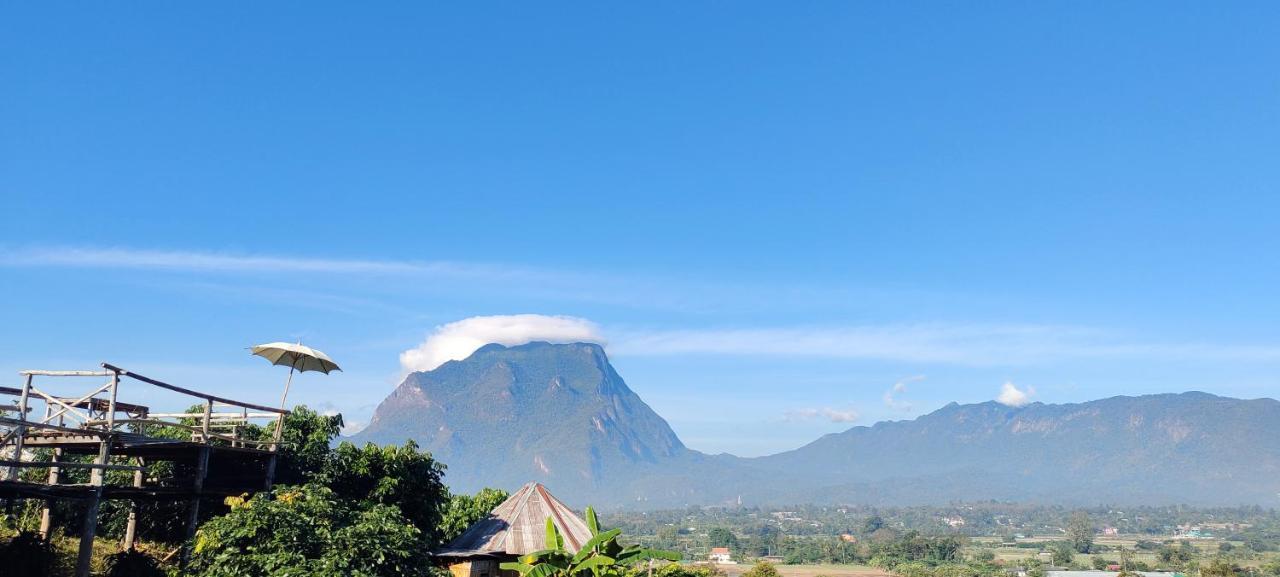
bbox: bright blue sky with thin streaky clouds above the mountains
[0,1,1280,454]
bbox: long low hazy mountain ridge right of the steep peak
[753,393,1280,505]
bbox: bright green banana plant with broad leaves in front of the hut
[499,507,680,577]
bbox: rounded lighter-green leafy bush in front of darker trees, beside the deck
[189,485,429,577]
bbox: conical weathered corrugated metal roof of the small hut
[435,482,591,557]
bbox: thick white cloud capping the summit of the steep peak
[401,315,604,374]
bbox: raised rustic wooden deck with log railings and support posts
[0,363,288,577]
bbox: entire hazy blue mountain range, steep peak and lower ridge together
[356,343,1280,507]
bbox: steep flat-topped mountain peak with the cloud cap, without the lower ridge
[355,343,696,506]
